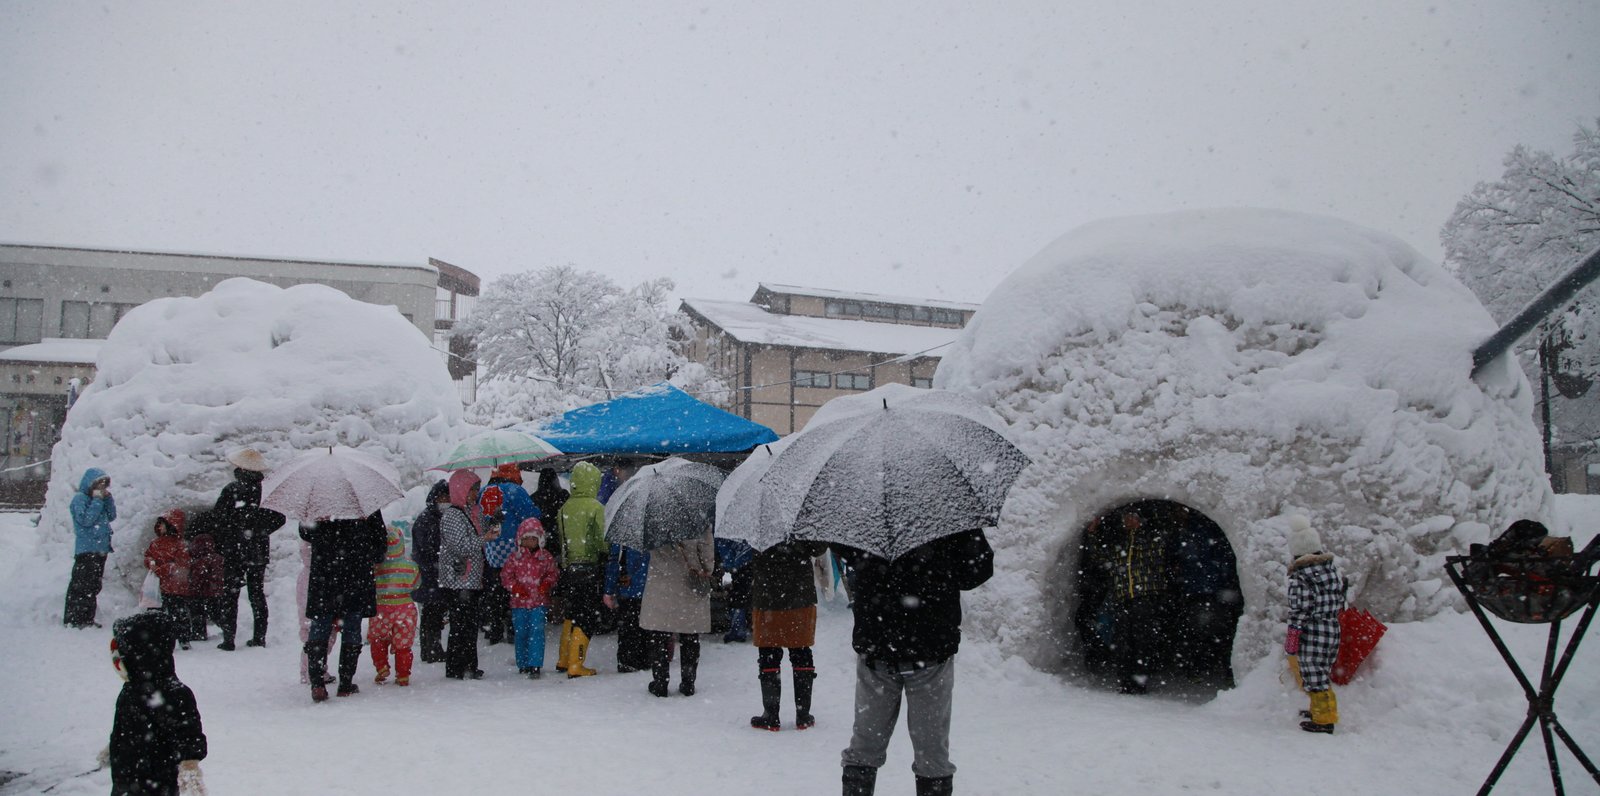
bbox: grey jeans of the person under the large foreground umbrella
[840,655,955,777]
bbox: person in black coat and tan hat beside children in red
[209,448,285,651]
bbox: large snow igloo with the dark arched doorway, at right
[934,209,1552,675]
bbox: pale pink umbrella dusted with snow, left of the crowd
[261,446,405,523]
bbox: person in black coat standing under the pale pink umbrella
[301,511,389,702]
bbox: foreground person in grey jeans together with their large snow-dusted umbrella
[734,384,1029,796]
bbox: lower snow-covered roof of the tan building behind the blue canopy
[683,299,960,356]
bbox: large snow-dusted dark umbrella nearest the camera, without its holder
[762,384,1029,559]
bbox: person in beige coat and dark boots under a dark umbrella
[638,529,717,697]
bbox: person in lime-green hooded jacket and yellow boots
[555,462,611,678]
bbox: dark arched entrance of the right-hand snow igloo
[1072,500,1245,694]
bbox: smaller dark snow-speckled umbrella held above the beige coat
[605,459,725,550]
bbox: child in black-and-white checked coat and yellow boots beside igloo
[1283,515,1344,732]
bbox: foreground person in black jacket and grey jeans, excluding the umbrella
[834,529,994,796]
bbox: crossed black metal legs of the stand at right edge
[1445,556,1600,796]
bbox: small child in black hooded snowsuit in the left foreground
[107,611,206,796]
